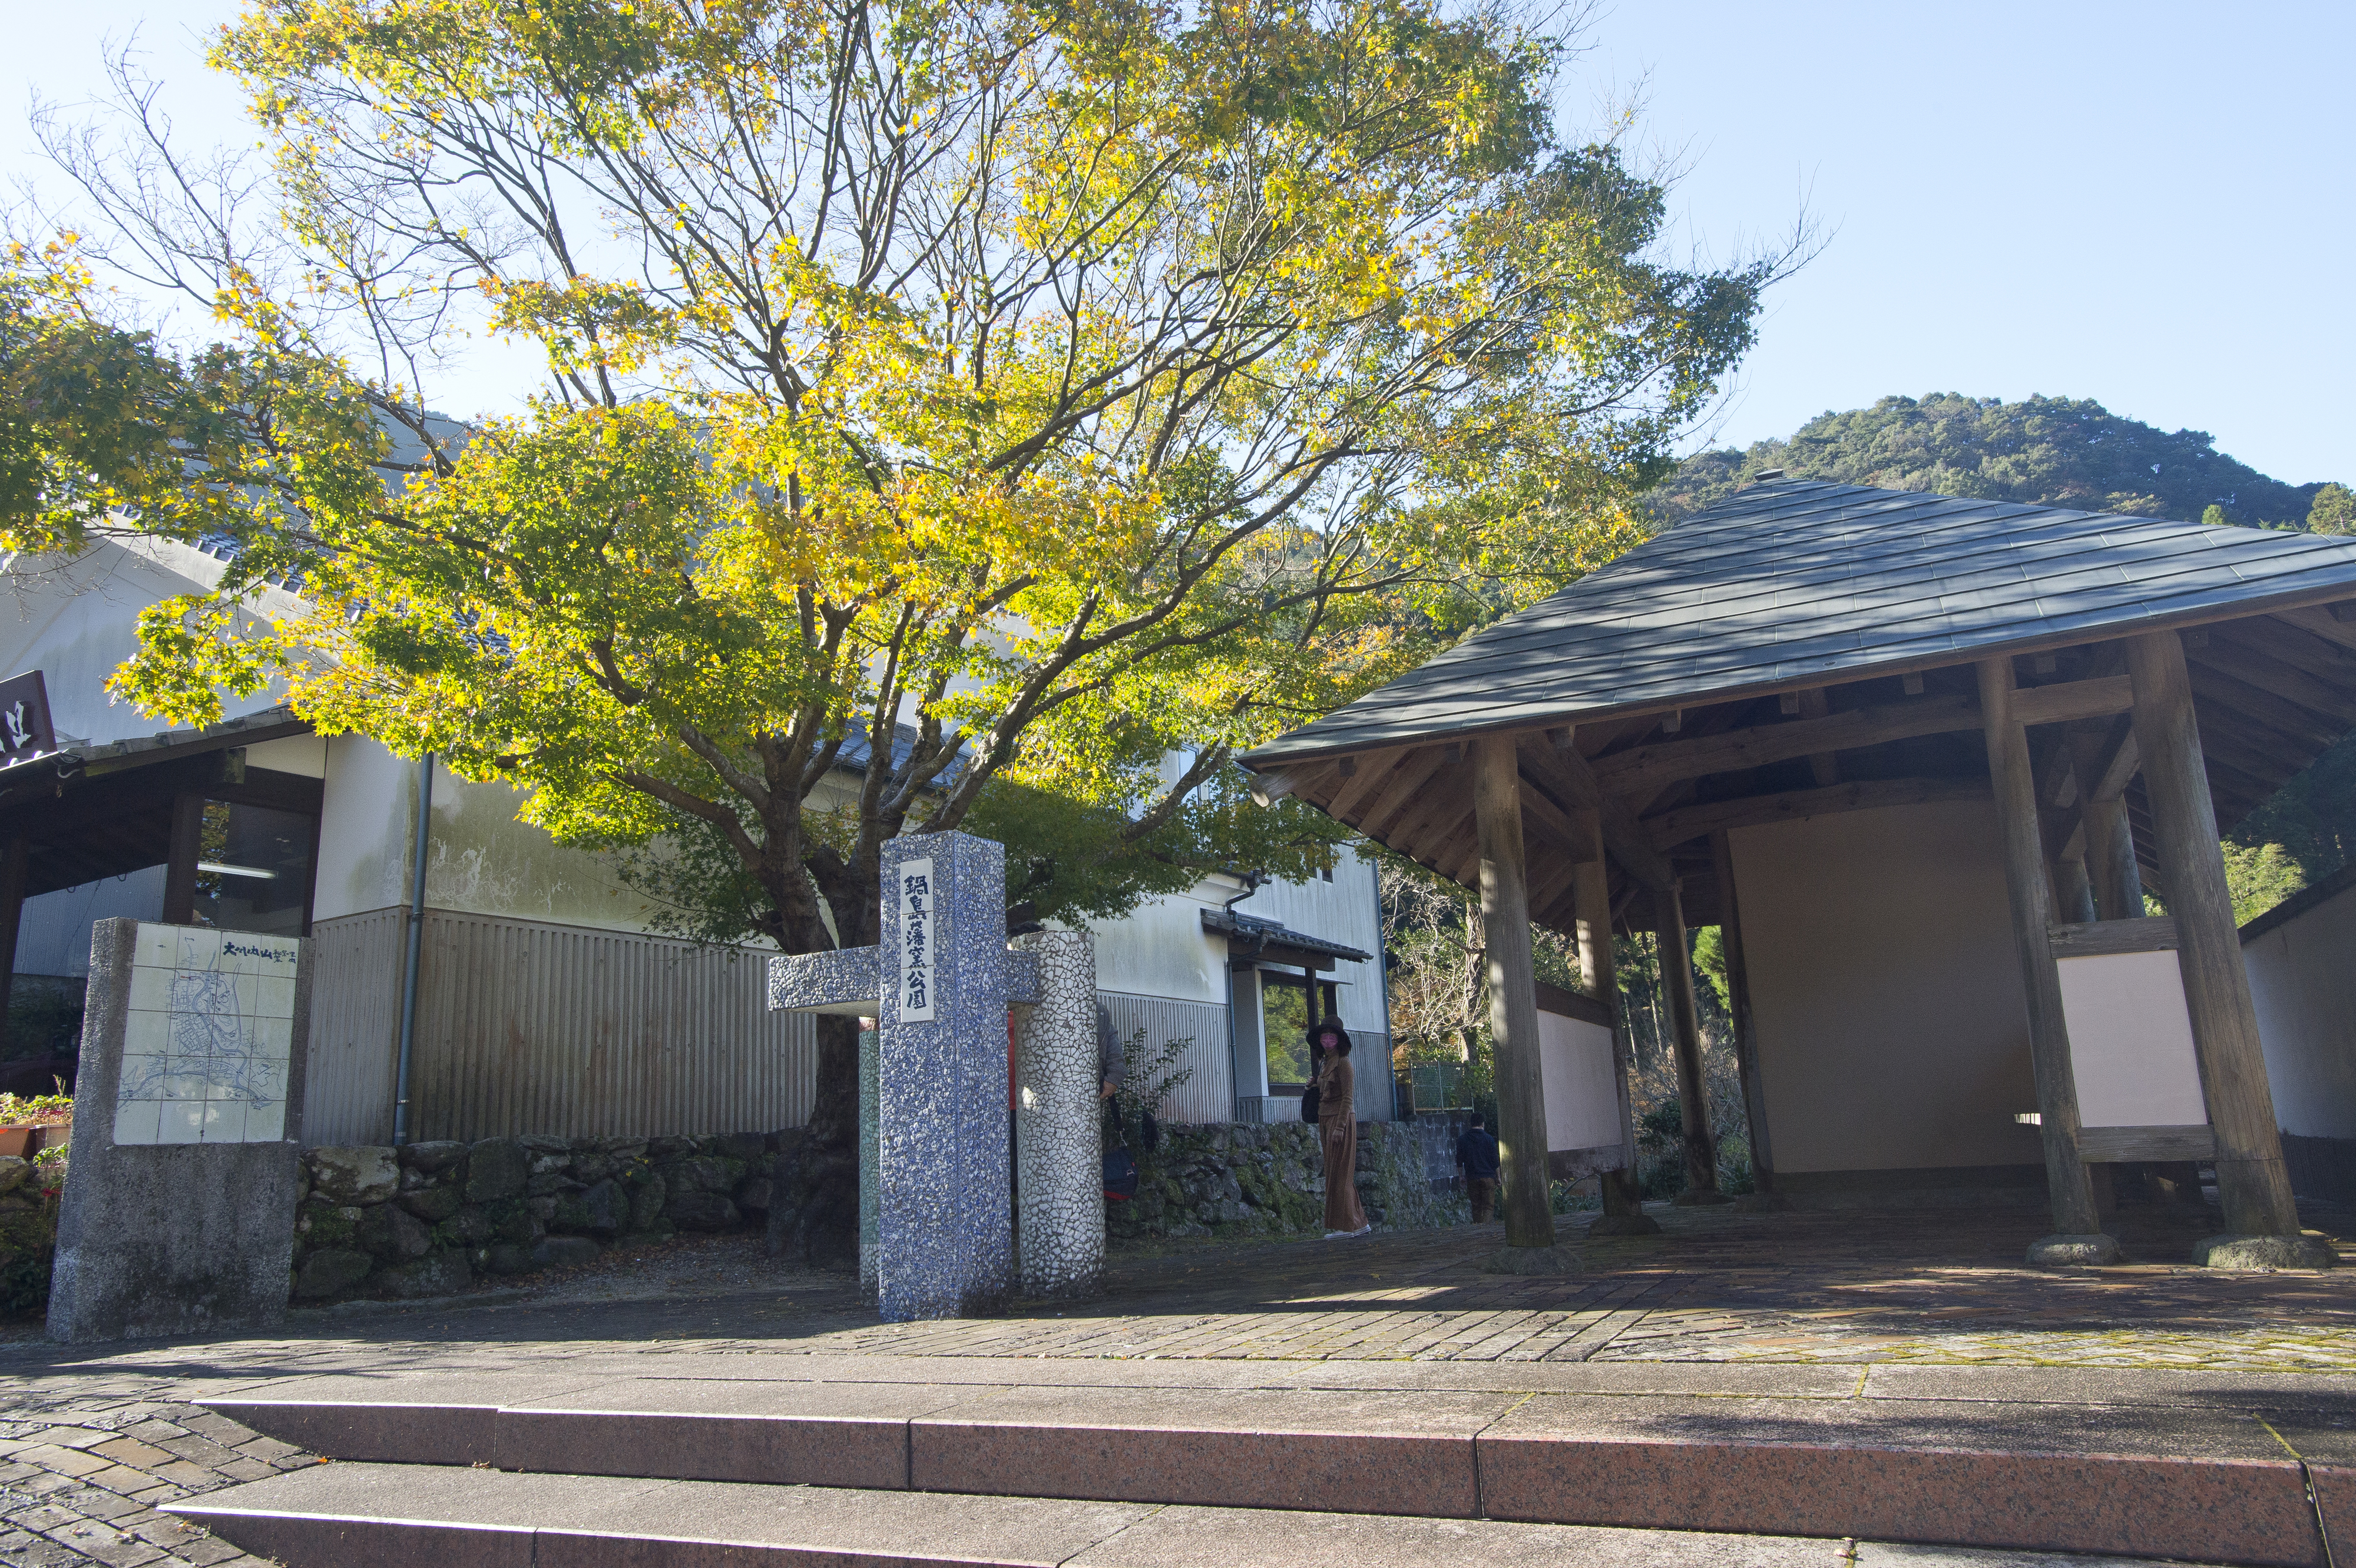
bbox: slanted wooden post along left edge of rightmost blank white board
[1979,657,2102,1259]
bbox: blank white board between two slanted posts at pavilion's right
[2059,954,2208,1128]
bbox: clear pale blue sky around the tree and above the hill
[18,0,2356,482]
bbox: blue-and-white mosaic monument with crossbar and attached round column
[768,833,1105,1323]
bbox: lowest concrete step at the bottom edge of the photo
[172,1464,2205,1568]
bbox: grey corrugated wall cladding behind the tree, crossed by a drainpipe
[304,909,815,1144]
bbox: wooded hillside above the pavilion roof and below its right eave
[1652,393,2356,914]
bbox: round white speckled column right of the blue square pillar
[1015,930,1105,1297]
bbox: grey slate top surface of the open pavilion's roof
[1242,480,2356,770]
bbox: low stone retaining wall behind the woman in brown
[1107,1121,1470,1240]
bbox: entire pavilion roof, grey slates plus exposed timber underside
[1242,480,2356,928]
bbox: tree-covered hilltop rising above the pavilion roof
[1654,393,2344,527]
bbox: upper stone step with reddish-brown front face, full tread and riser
[205,1375,2356,1568]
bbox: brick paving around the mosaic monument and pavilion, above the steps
[0,1208,2356,1568]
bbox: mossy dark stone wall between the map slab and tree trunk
[292,1130,782,1302]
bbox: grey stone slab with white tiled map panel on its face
[49,921,311,1344]
